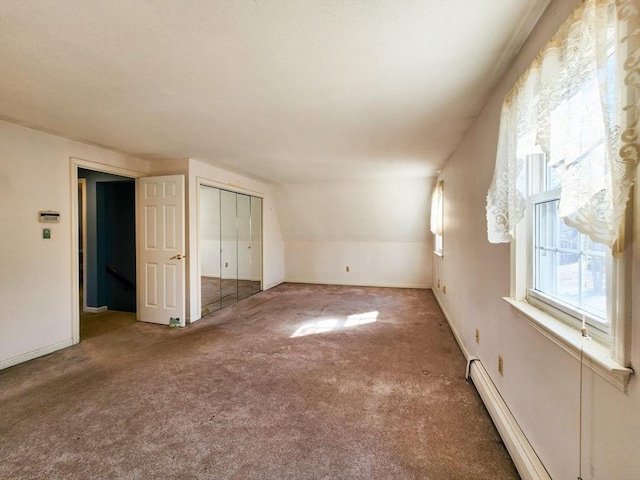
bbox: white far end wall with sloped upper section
[276,178,433,288]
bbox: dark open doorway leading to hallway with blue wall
[77,168,136,341]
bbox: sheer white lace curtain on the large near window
[487,0,640,255]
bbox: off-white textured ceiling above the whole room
[0,0,548,183]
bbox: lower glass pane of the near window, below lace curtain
[534,200,609,324]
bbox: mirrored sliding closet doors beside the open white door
[199,184,262,315]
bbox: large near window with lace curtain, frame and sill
[487,0,640,388]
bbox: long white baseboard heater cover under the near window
[467,357,551,480]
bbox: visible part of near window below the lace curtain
[525,154,616,345]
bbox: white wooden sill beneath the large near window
[503,297,633,393]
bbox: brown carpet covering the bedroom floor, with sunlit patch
[0,284,518,480]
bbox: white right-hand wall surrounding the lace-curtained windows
[433,1,640,480]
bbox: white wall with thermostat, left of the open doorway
[0,122,146,368]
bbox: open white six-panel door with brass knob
[136,175,186,326]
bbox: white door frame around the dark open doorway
[70,157,146,344]
